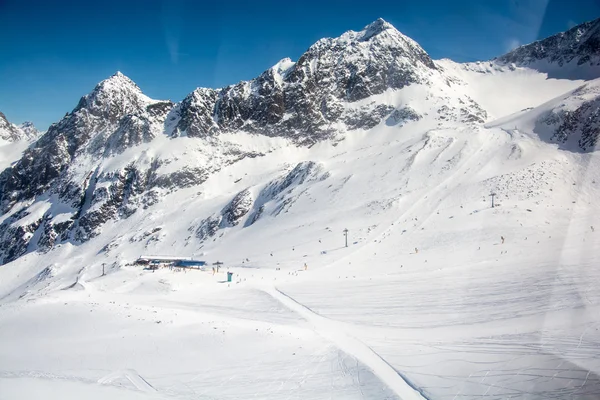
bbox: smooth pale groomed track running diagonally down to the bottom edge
[262,287,426,400]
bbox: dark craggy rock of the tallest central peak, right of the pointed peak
[177,19,438,144]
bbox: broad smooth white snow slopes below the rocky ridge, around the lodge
[0,66,600,400]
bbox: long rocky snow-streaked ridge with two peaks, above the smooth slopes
[0,19,597,263]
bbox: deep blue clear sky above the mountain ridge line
[0,0,600,129]
